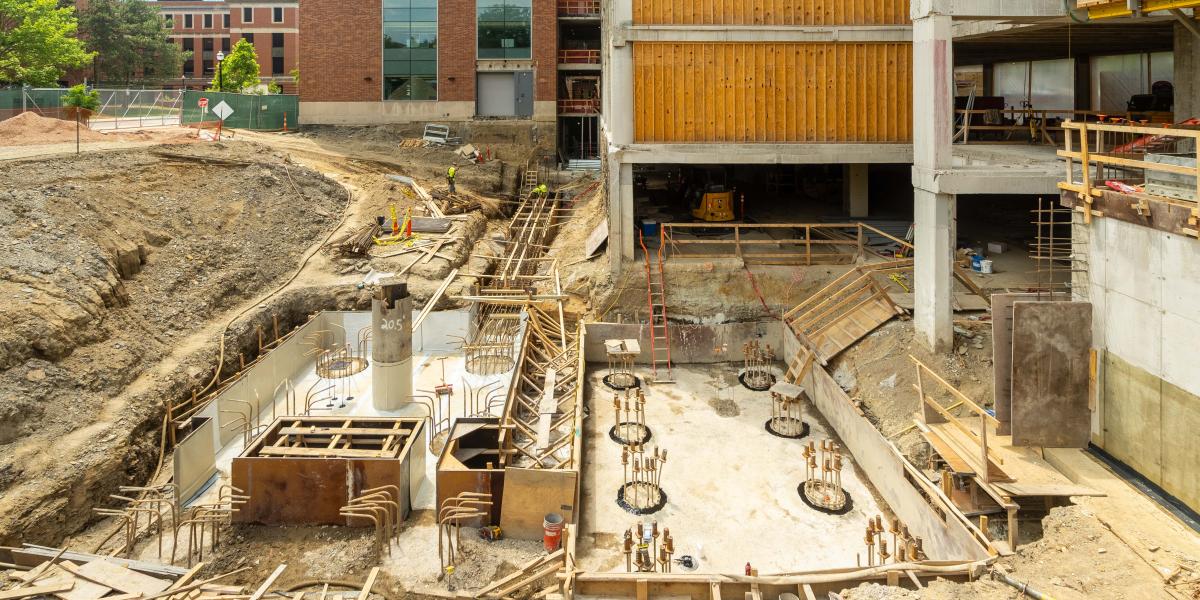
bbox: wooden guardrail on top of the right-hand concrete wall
[1058,121,1200,224]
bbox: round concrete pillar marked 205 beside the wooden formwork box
[371,280,413,410]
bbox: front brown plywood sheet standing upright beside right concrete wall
[1012,301,1092,448]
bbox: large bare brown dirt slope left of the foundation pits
[0,144,354,544]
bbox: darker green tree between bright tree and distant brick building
[80,0,191,84]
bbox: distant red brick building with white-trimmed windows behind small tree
[150,0,299,94]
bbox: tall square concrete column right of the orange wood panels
[912,12,955,352]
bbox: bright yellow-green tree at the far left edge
[0,0,91,85]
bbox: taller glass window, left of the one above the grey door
[383,0,438,100]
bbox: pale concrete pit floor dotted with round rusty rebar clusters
[576,362,890,574]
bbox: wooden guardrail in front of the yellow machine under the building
[661,222,912,265]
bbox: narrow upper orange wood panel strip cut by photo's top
[634,0,908,25]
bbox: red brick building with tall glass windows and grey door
[300,0,600,147]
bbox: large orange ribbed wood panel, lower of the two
[634,42,912,143]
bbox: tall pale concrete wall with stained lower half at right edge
[1073,213,1200,508]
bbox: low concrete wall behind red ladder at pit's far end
[583,320,784,365]
